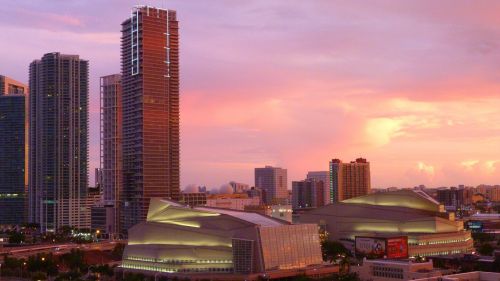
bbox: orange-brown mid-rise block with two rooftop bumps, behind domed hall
[330,158,371,202]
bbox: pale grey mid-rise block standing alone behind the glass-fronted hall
[255,166,288,205]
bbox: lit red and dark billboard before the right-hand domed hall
[355,236,408,259]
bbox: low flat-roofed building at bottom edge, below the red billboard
[350,259,441,281]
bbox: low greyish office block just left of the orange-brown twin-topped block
[292,179,325,210]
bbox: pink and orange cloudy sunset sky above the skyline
[0,0,500,188]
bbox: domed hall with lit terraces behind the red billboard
[299,190,474,256]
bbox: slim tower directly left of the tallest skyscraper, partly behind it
[101,74,123,234]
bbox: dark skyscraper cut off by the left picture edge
[0,76,28,225]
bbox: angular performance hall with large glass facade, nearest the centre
[121,199,323,280]
